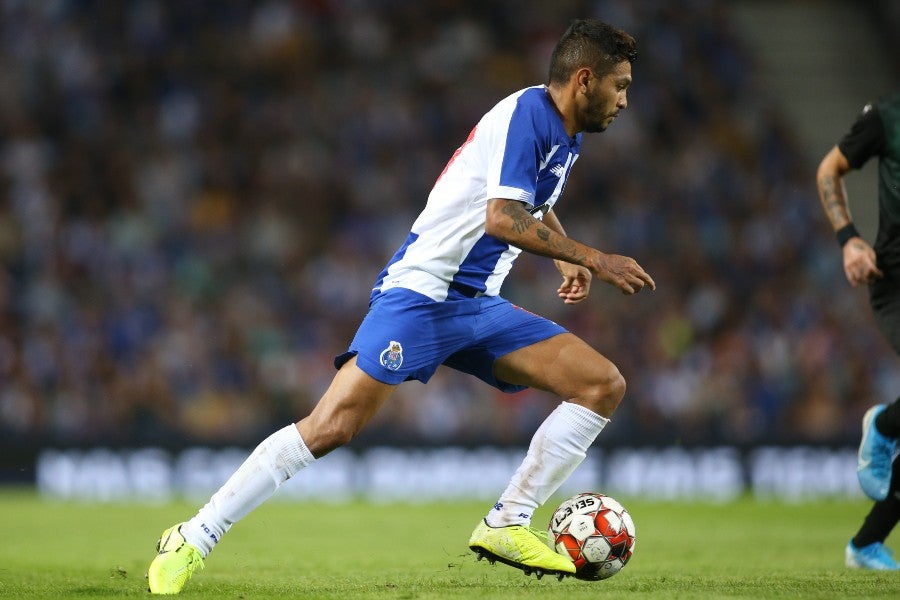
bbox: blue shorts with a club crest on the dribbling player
[334,288,566,392]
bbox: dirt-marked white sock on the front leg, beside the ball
[485,402,609,527]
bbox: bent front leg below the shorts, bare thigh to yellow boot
[469,333,625,576]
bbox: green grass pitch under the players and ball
[0,491,900,600]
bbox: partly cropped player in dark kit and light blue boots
[816,93,900,570]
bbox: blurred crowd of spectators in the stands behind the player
[0,0,900,444]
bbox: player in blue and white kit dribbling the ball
[148,19,656,594]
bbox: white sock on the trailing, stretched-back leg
[181,424,315,557]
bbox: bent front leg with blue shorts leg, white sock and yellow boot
[464,302,624,576]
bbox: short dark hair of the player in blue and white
[550,19,637,84]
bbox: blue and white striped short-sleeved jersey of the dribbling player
[372,86,581,301]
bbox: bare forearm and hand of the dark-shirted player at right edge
[816,146,884,287]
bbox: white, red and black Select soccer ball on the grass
[548,492,635,581]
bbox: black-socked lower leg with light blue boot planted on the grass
[844,458,900,571]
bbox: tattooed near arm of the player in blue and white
[485,198,656,301]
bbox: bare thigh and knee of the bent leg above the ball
[494,333,617,398]
